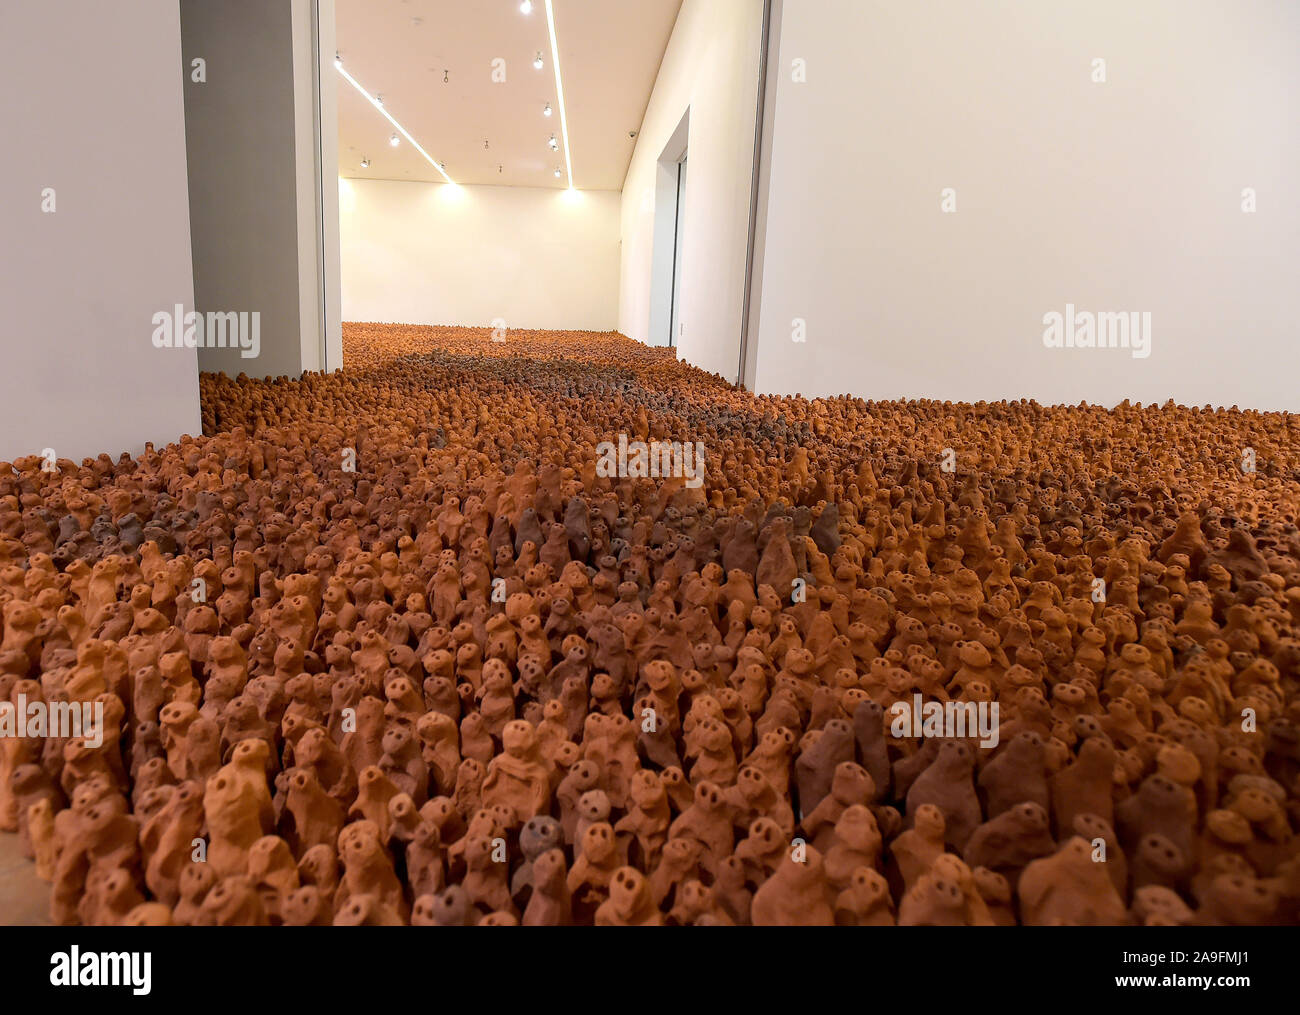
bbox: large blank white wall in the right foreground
[748,0,1300,409]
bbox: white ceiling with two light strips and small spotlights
[337,0,681,190]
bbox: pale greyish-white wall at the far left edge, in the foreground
[0,0,202,461]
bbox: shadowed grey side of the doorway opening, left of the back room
[181,0,342,377]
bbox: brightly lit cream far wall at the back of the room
[339,179,620,331]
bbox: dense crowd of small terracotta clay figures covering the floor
[0,325,1300,925]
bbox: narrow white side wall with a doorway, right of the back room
[619,0,763,379]
